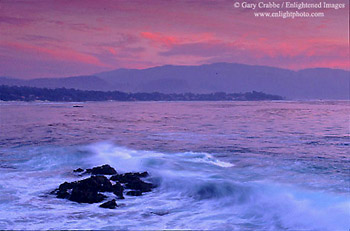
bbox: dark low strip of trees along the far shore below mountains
[0,85,283,102]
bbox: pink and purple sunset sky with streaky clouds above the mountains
[0,0,349,79]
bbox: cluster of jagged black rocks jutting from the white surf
[52,164,156,209]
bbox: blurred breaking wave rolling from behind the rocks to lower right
[82,143,350,230]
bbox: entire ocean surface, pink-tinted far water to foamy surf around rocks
[0,101,350,231]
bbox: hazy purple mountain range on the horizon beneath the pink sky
[0,63,350,99]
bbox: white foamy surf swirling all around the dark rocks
[0,142,350,230]
